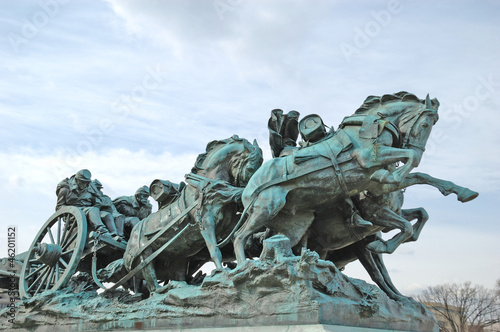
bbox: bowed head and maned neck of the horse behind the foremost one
[191,135,263,187]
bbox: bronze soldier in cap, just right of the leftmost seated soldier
[113,186,153,237]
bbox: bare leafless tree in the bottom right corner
[417,279,500,332]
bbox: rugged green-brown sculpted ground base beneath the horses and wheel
[0,237,438,332]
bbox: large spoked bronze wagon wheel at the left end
[19,206,87,298]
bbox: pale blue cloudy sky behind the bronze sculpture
[0,0,500,294]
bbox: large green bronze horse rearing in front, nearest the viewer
[234,92,439,267]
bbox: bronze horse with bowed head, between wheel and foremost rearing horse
[123,135,262,292]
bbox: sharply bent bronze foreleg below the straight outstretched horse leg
[366,206,413,254]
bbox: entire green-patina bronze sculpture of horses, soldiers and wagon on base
[1,91,478,330]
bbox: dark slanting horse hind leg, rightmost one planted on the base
[352,241,404,301]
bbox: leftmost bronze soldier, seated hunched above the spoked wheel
[56,169,121,236]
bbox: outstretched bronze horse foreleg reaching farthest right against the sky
[399,172,479,203]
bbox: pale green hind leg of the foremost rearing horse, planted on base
[233,187,286,268]
